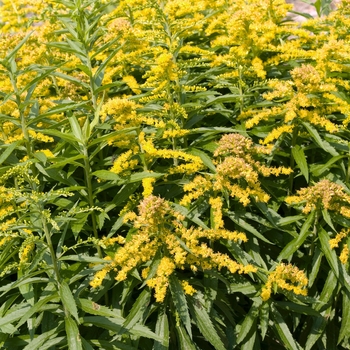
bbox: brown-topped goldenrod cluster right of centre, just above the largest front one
[181,134,292,206]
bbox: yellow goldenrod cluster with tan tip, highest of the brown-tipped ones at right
[240,64,340,144]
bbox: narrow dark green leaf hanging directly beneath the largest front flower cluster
[169,275,192,339]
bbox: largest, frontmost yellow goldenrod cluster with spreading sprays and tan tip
[90,195,256,302]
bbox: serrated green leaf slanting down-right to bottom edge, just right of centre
[188,292,225,350]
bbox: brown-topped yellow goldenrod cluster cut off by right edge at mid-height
[285,179,350,218]
